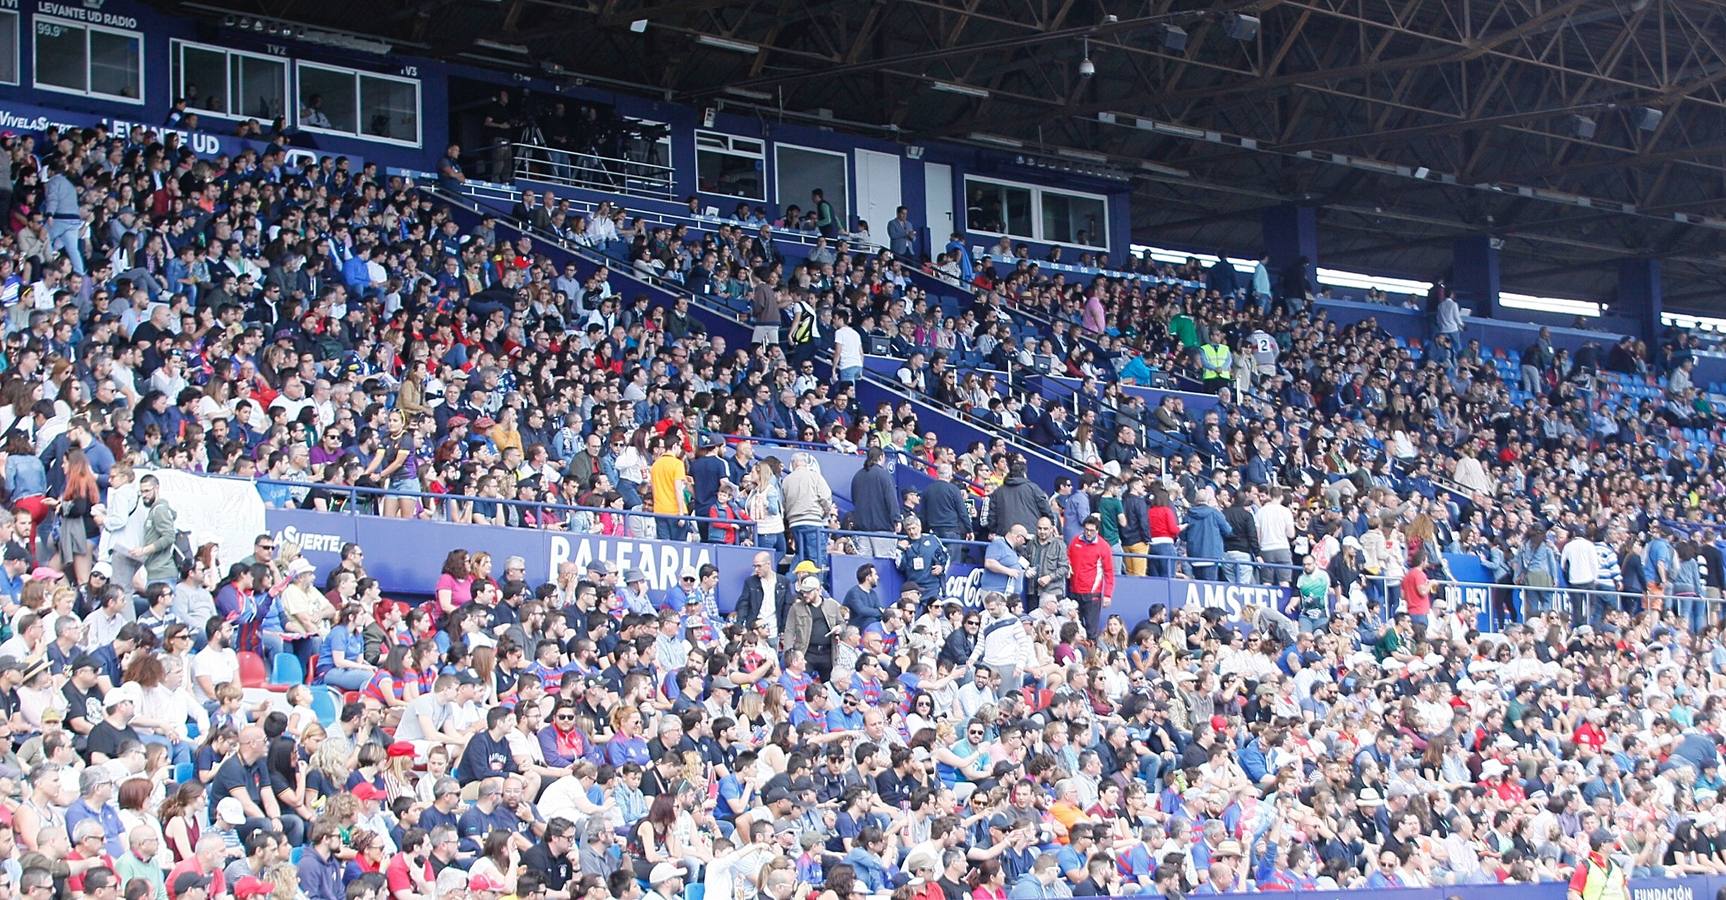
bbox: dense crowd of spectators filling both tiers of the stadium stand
[0,112,1698,900]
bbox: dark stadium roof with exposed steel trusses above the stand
[159,0,1726,309]
